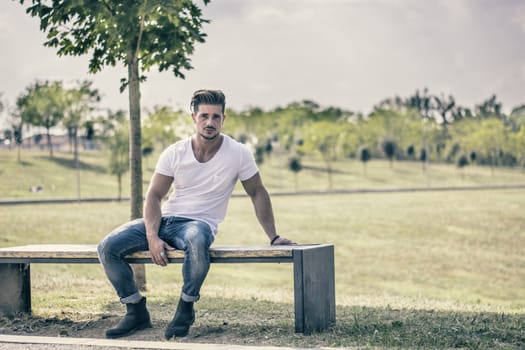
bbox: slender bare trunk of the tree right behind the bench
[128,44,146,291]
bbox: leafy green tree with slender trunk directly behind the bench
[20,0,209,223]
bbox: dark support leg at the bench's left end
[0,264,31,316]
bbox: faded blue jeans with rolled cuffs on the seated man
[98,216,214,303]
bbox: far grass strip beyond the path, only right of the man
[255,155,525,192]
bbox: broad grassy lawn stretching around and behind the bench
[0,149,525,349]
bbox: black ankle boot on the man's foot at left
[106,297,152,339]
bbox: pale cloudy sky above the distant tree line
[0,0,525,119]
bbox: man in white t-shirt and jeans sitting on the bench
[98,90,293,339]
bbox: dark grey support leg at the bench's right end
[293,246,335,334]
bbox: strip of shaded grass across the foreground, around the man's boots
[0,298,525,349]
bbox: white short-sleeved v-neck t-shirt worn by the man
[155,135,259,234]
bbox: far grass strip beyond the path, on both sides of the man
[0,150,525,200]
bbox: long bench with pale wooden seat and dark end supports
[0,244,335,334]
